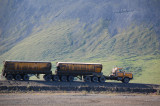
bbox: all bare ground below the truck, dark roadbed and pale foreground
[0,80,160,106]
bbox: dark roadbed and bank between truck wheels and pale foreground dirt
[0,80,160,94]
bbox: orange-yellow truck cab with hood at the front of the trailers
[110,67,133,83]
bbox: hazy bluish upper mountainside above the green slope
[0,0,160,54]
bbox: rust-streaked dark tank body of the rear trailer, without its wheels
[3,61,51,74]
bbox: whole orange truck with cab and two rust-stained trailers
[2,61,133,83]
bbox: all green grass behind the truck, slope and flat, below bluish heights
[0,19,160,84]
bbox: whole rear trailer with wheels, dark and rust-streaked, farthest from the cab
[2,60,52,81]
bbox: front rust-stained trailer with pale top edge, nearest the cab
[52,62,105,82]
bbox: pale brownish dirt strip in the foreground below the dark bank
[0,93,160,106]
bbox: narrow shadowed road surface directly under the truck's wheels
[0,80,160,88]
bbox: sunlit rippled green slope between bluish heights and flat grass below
[1,20,159,61]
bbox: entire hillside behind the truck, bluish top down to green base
[0,0,160,83]
